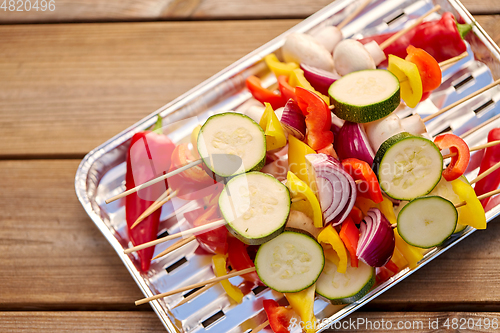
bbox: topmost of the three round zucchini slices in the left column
[197,112,266,177]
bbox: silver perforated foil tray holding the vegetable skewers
[75,0,500,333]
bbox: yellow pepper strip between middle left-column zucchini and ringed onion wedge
[286,171,323,228]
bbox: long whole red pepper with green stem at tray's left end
[125,118,175,272]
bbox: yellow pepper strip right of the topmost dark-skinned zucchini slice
[387,54,423,108]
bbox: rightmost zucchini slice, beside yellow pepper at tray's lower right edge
[398,196,458,249]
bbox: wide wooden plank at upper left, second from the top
[0,20,299,157]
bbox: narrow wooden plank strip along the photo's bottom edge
[0,311,500,333]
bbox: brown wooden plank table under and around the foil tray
[0,0,500,332]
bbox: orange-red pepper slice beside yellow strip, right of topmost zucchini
[406,45,442,92]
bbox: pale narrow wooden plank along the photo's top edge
[0,0,500,23]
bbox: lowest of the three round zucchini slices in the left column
[255,231,325,293]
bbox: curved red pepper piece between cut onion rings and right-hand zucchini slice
[342,157,384,203]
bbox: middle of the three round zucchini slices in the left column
[219,171,290,245]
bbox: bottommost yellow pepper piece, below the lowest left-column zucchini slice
[285,283,316,333]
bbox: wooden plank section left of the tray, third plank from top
[0,160,142,310]
